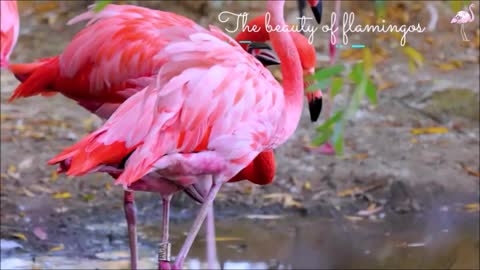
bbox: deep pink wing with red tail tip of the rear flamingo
[10,4,197,103]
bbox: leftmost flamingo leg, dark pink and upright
[123,191,138,270]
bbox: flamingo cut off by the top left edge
[0,0,19,68]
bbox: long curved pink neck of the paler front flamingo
[266,0,303,144]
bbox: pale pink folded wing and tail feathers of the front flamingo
[50,27,285,185]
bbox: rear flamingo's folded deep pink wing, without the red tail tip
[60,4,199,96]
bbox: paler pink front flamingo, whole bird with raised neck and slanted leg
[50,1,303,268]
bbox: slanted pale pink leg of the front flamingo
[174,183,222,269]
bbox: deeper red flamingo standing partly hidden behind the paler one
[2,2,275,268]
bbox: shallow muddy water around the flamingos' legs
[1,208,479,269]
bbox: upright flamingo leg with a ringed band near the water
[158,195,172,270]
